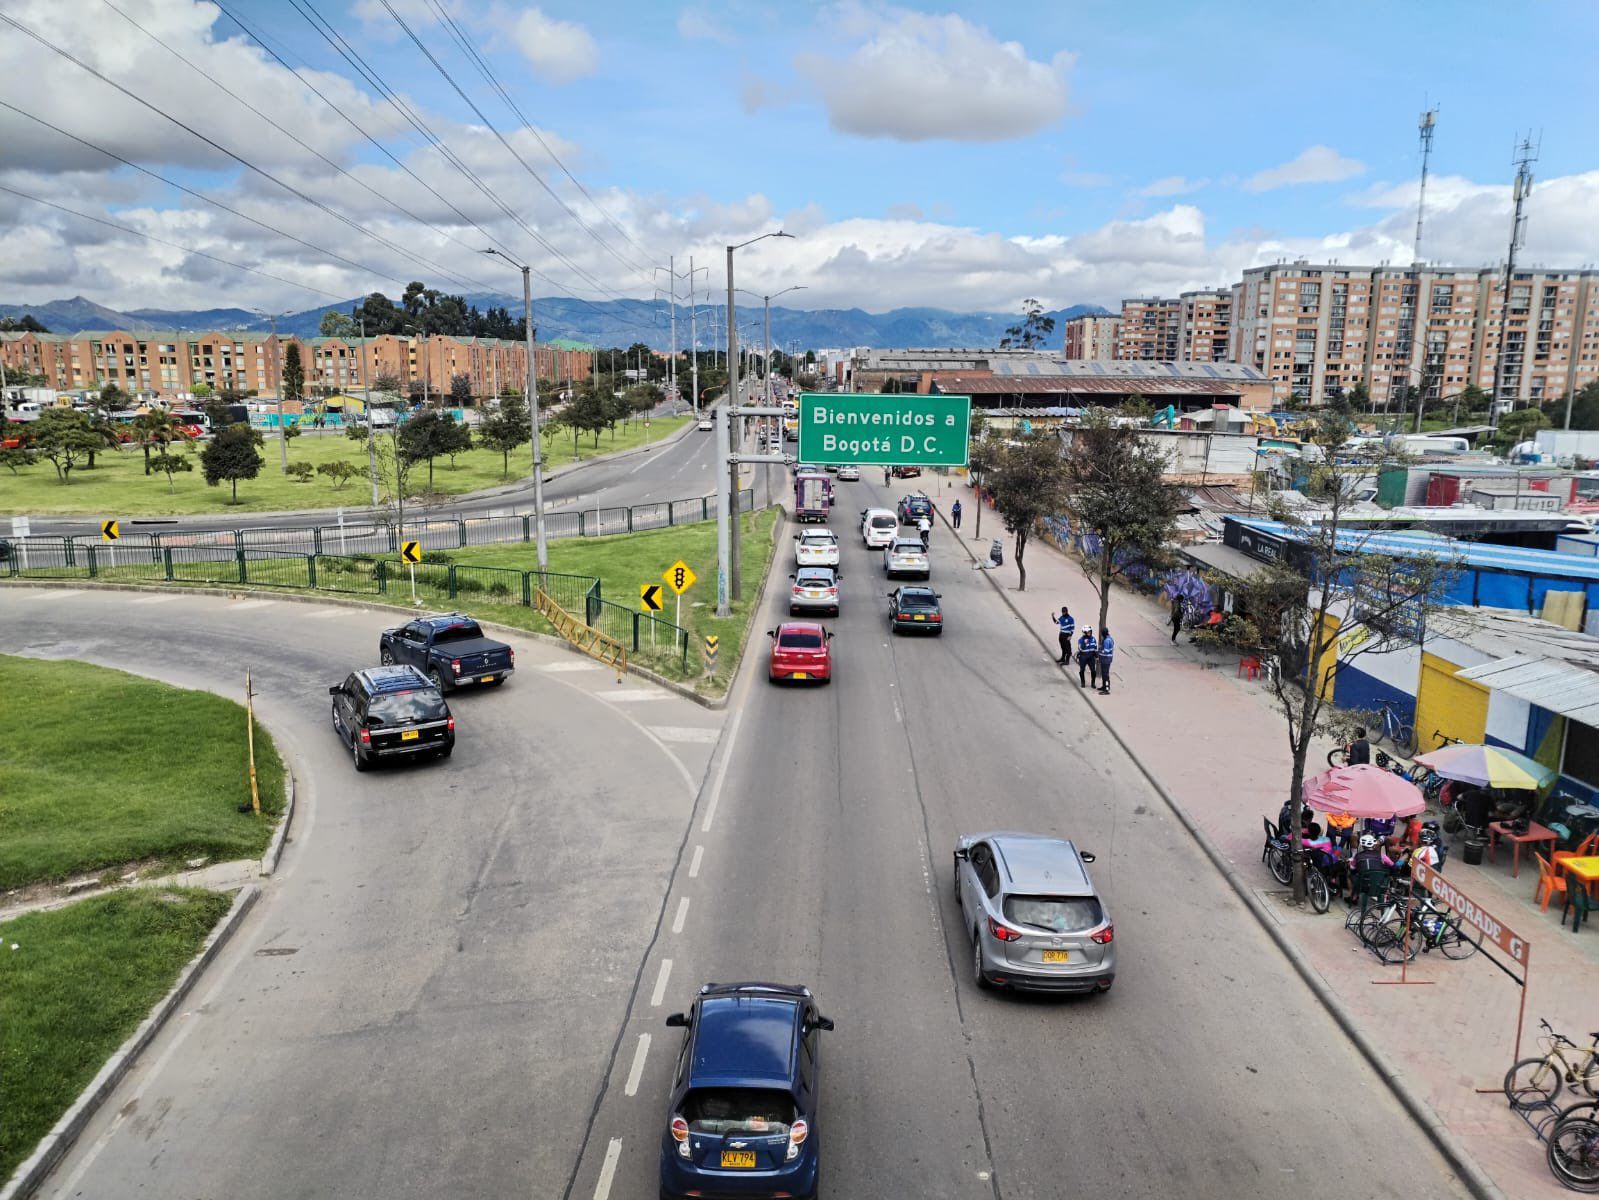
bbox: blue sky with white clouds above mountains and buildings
[0,0,1599,320]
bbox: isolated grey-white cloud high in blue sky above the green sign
[795,3,1075,142]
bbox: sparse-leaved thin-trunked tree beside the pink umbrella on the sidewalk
[1208,411,1455,899]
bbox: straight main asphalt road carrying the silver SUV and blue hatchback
[564,477,1466,1200]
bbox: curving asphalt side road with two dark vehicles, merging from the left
[0,589,721,1200]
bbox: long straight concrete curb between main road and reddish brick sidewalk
[933,499,1506,1200]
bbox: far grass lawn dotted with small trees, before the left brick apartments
[0,416,689,517]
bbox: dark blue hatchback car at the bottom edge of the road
[660,982,833,1200]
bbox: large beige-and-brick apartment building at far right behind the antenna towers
[1230,262,1599,408]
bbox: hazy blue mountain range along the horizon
[0,294,1105,350]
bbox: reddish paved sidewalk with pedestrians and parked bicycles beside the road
[939,485,1599,1200]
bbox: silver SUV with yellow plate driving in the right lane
[955,834,1116,992]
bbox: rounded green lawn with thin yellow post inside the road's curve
[0,656,285,890]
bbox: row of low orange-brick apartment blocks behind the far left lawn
[0,330,593,398]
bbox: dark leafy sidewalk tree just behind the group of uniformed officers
[1065,408,1182,630]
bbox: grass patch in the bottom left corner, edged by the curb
[0,896,232,1181]
